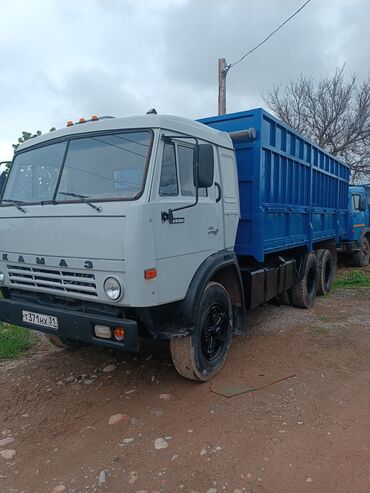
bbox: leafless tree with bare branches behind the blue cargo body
[264,66,370,183]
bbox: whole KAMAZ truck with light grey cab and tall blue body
[0,109,360,381]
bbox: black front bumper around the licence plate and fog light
[0,299,139,351]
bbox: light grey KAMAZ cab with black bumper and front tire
[0,114,243,380]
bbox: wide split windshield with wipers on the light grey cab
[3,130,152,203]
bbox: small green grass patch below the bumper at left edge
[0,324,34,360]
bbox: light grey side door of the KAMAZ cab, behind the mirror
[151,134,224,304]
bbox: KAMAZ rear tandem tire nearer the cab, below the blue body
[290,253,318,308]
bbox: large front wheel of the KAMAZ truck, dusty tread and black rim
[170,282,232,382]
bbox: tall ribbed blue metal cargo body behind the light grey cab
[199,108,350,262]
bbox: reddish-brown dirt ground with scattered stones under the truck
[0,280,370,493]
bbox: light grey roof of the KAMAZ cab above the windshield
[17,114,233,152]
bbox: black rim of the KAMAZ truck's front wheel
[201,302,229,361]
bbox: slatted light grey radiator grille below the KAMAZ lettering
[7,265,97,297]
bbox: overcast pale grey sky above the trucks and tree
[0,0,370,160]
